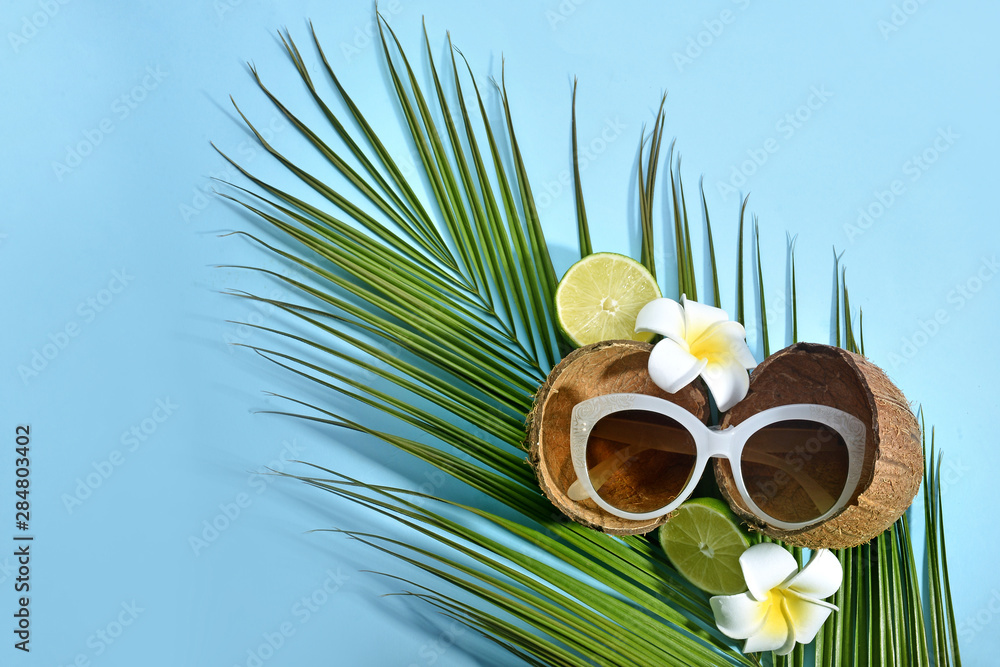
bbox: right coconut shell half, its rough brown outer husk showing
[715,343,924,549]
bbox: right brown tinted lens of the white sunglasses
[740,420,849,523]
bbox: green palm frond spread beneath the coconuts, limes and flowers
[223,16,960,666]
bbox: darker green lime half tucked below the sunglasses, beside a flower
[660,498,750,595]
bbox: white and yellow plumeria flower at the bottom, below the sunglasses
[709,542,844,655]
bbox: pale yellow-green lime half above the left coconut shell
[556,252,660,347]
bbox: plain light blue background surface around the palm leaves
[0,0,1000,666]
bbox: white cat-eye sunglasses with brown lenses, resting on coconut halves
[568,394,866,530]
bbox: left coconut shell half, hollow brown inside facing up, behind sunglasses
[528,340,709,535]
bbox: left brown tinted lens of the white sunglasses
[587,410,697,514]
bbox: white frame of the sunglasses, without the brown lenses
[570,394,867,530]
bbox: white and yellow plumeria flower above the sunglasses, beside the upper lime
[635,296,757,412]
